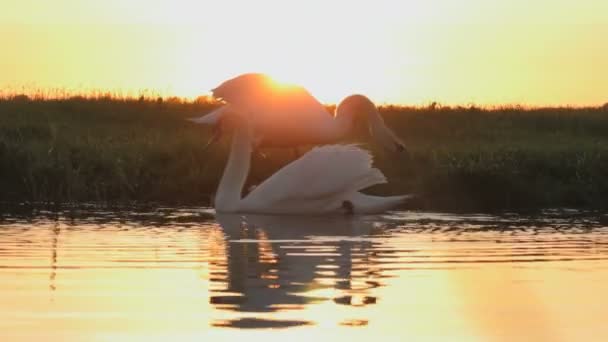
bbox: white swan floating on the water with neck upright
[214,119,410,214]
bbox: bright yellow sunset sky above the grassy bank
[0,0,608,105]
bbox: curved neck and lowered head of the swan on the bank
[336,94,407,153]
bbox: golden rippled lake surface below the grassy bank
[0,208,608,341]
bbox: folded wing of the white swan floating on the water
[244,145,386,206]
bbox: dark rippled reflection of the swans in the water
[210,214,390,327]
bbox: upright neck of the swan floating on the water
[215,125,252,212]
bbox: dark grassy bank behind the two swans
[0,97,608,210]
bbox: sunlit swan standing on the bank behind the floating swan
[189,73,406,151]
